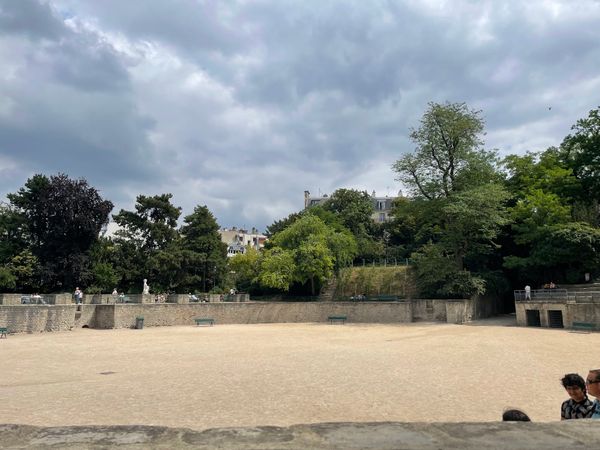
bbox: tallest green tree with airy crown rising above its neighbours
[394,103,509,297]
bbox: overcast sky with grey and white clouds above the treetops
[0,0,600,230]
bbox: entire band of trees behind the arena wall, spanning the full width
[0,103,600,298]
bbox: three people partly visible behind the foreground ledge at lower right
[502,369,600,422]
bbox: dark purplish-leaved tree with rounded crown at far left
[8,174,113,290]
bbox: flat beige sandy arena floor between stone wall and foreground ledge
[0,318,600,429]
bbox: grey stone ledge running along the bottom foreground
[0,420,600,450]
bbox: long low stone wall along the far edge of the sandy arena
[0,300,480,333]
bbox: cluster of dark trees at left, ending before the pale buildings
[0,174,227,292]
